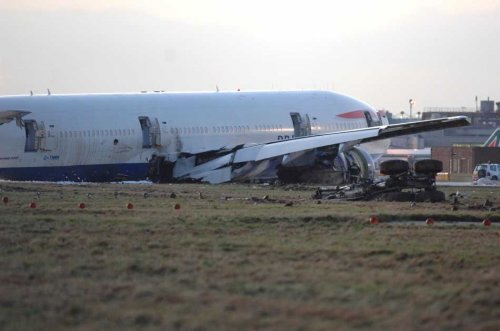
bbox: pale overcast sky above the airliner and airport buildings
[0,0,500,113]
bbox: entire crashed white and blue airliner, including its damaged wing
[0,91,469,183]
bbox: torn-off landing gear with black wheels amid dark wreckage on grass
[313,159,446,202]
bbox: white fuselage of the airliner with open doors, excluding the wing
[0,91,387,180]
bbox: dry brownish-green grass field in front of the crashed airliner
[0,182,500,331]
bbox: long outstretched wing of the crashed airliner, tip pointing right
[233,116,470,163]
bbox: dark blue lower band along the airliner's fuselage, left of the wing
[0,163,148,182]
